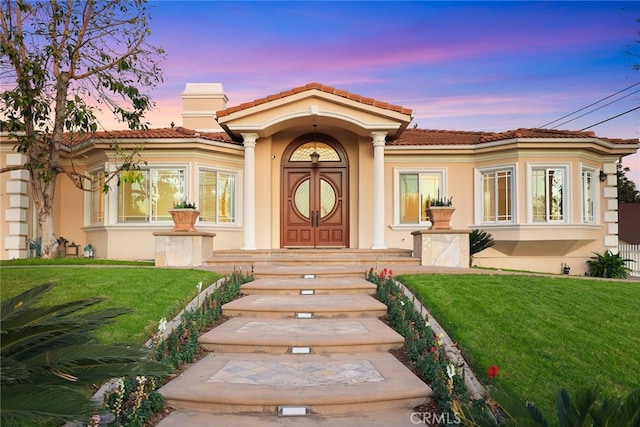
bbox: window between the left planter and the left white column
[198,170,236,223]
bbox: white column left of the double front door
[242,133,258,250]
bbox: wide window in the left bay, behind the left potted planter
[118,168,186,222]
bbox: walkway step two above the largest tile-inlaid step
[222,294,387,319]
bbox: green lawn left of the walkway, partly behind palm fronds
[0,266,222,343]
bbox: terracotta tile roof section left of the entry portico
[63,126,235,146]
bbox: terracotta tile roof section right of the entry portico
[387,128,638,146]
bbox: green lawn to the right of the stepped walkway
[399,274,640,419]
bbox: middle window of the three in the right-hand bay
[531,168,565,222]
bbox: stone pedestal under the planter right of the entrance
[411,230,470,268]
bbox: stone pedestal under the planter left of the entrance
[153,231,215,267]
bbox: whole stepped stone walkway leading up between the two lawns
[159,267,431,427]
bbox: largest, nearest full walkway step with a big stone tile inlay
[161,352,431,416]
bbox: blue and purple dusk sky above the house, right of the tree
[110,1,640,185]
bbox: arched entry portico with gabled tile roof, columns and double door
[216,83,412,250]
